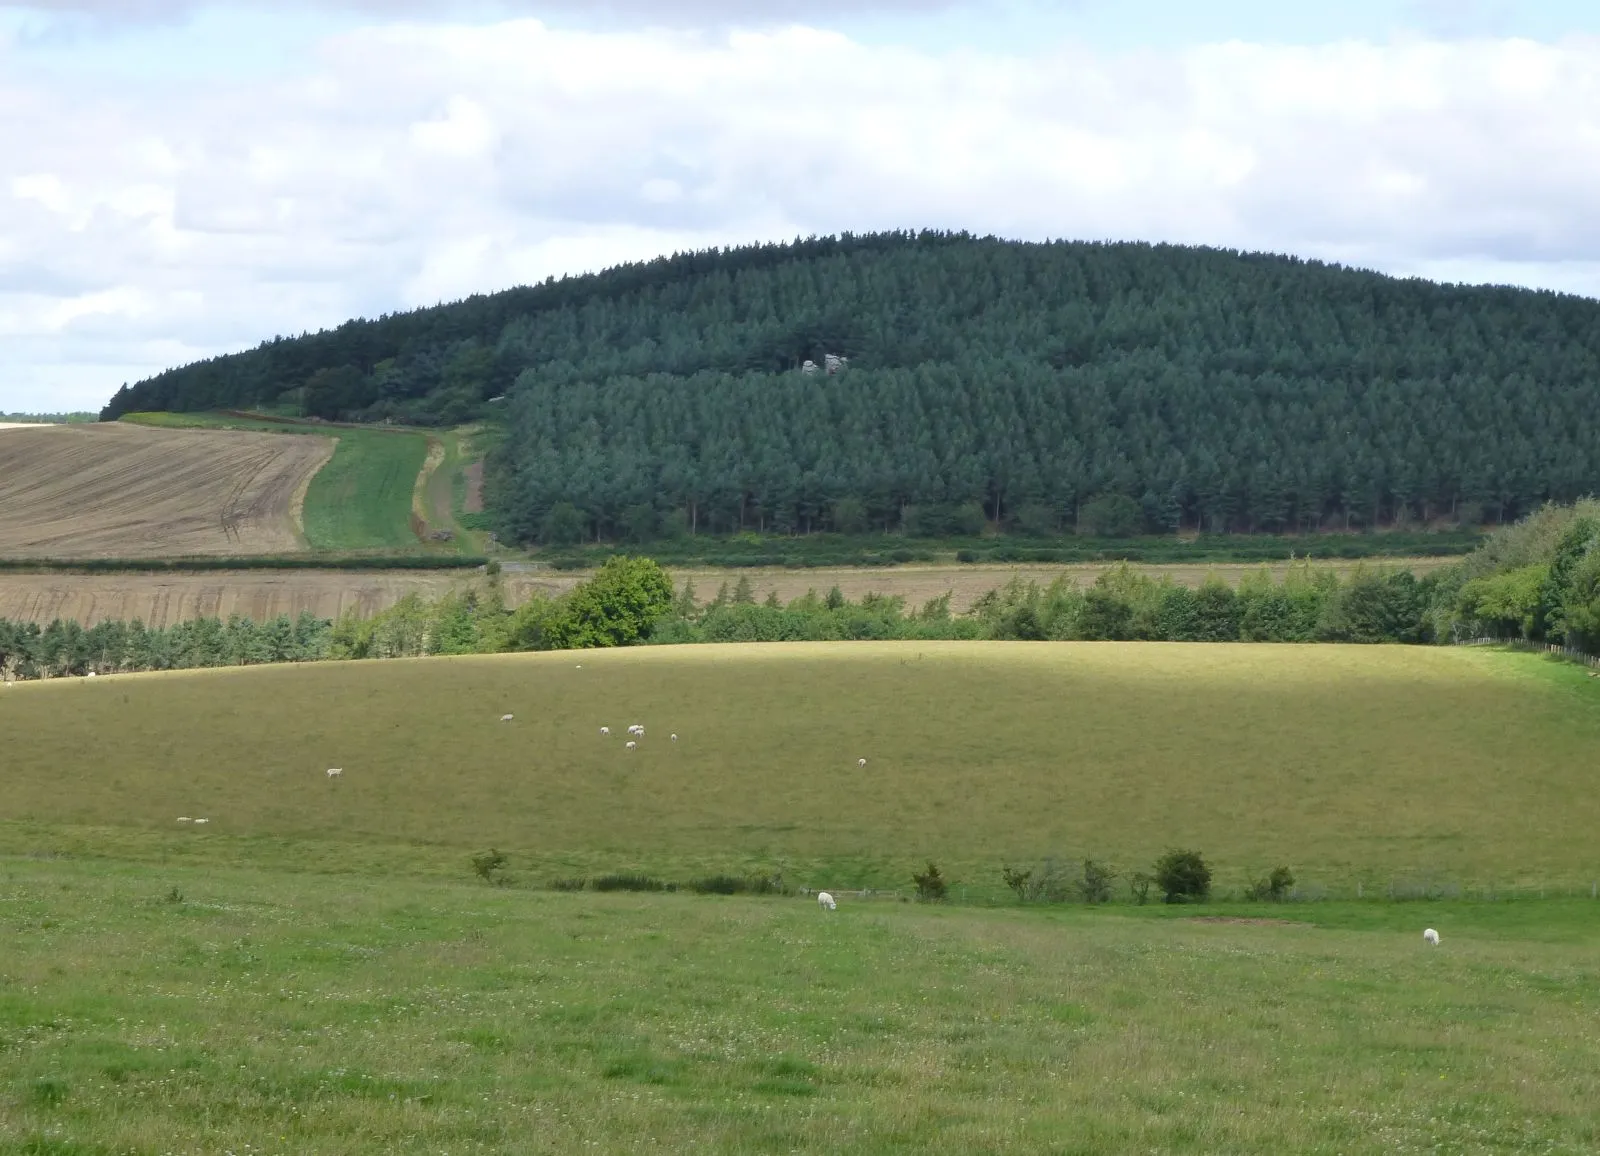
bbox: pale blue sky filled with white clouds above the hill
[0,0,1600,411]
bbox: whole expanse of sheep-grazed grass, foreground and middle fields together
[0,644,1600,1156]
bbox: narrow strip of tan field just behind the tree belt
[0,557,1448,626]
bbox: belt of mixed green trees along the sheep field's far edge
[0,501,1600,679]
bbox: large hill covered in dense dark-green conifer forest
[104,234,1600,541]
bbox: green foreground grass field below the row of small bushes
[0,858,1600,1156]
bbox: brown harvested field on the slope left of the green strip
[0,423,334,559]
